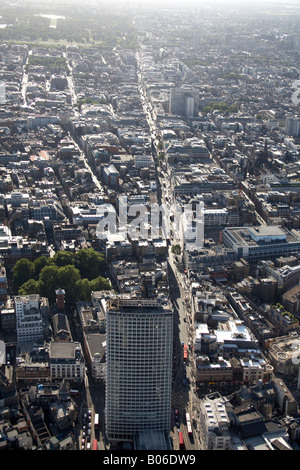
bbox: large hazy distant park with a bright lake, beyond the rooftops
[0,1,137,49]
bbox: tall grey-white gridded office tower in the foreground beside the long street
[105,295,173,441]
